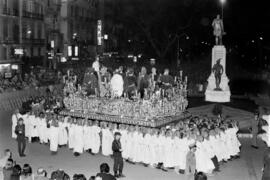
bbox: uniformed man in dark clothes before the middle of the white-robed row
[112,132,125,178]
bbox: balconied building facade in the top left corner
[0,0,45,67]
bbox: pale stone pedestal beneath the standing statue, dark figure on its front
[205,46,231,102]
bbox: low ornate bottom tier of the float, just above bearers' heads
[60,110,190,128]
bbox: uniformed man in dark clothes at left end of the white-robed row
[15,118,26,157]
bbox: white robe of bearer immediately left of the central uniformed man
[102,128,113,156]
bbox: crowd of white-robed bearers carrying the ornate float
[12,105,241,174]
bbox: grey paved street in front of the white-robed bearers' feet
[0,109,266,180]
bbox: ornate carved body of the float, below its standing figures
[60,79,189,127]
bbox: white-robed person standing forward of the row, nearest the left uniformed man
[50,117,59,155]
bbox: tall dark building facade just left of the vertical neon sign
[60,0,98,59]
